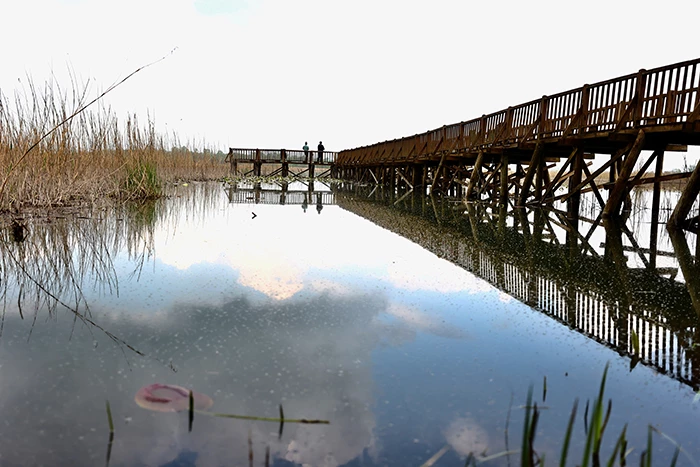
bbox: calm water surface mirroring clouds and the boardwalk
[0,184,700,467]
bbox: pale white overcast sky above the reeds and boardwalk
[0,0,700,164]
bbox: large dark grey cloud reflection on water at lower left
[0,293,386,466]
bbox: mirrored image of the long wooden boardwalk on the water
[338,188,700,388]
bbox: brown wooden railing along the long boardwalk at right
[337,59,700,166]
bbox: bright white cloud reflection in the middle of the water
[156,205,492,300]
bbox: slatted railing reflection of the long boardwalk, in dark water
[338,195,700,388]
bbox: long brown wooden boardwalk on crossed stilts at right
[332,59,700,228]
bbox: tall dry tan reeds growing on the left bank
[0,73,228,211]
